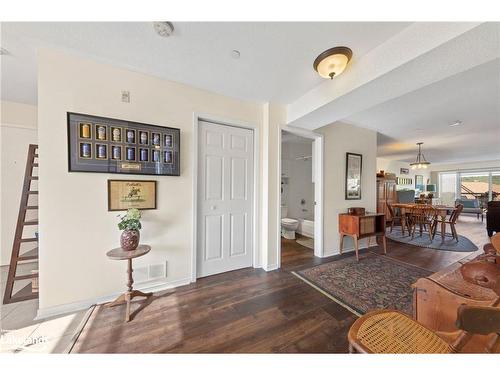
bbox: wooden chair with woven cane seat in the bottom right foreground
[348,278,500,354]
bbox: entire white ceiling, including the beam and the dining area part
[0,22,500,163]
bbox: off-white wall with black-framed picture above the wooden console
[316,122,377,256]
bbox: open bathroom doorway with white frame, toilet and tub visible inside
[279,127,323,264]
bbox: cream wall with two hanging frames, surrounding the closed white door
[38,50,268,311]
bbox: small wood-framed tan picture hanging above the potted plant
[108,180,156,211]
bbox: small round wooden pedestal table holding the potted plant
[105,245,153,322]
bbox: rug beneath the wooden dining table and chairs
[386,227,477,253]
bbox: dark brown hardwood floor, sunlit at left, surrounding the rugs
[72,218,488,353]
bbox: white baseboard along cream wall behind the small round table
[35,277,191,320]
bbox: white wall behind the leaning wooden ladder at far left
[0,101,38,265]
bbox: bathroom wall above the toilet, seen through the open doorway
[281,142,314,219]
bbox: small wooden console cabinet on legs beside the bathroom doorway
[339,213,387,261]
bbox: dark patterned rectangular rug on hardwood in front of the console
[292,253,432,316]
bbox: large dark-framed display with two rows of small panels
[67,112,180,176]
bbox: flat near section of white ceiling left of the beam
[1,22,410,104]
